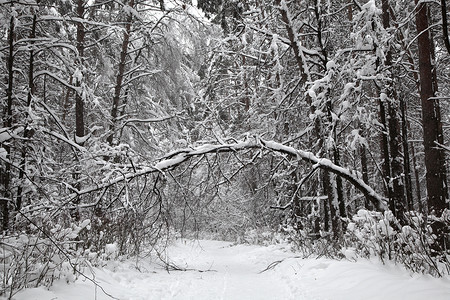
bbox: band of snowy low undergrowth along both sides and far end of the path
[0,210,450,299]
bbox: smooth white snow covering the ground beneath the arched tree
[7,240,450,300]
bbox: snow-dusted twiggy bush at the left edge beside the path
[0,220,90,299]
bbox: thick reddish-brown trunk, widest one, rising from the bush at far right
[415,0,448,216]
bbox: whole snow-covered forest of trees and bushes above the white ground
[0,0,450,299]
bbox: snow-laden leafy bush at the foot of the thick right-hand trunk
[342,209,450,276]
